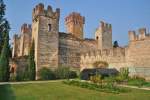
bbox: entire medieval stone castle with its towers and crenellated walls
[12,3,150,79]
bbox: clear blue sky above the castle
[4,0,150,45]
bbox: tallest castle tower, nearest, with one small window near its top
[32,3,60,79]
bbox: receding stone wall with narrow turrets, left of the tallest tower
[12,24,32,57]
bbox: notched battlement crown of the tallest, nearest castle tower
[32,3,60,20]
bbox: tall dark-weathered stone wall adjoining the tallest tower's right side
[59,33,97,68]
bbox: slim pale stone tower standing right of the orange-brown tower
[95,21,112,49]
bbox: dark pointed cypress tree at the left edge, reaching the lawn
[0,33,10,81]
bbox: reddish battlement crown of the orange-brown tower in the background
[65,12,85,24]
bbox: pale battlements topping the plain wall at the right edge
[128,28,150,41]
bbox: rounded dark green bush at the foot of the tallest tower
[39,67,56,80]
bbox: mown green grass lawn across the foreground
[0,82,150,100]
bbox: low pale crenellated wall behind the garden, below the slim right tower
[80,48,128,70]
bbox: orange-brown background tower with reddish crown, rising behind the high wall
[65,12,85,39]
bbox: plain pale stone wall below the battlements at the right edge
[127,40,150,67]
